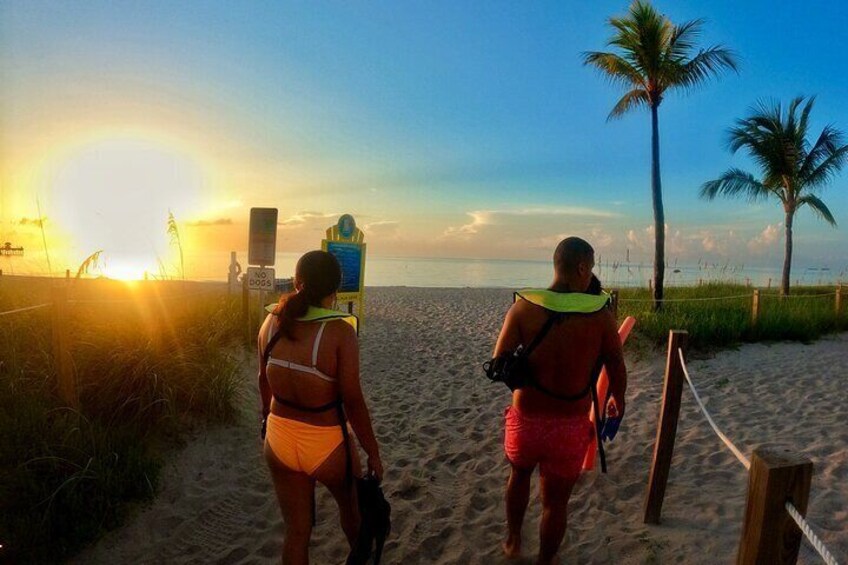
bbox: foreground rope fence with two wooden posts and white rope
[645,331,839,565]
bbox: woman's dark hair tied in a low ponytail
[274,251,342,340]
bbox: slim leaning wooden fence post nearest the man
[644,330,689,524]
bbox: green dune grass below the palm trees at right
[619,283,848,348]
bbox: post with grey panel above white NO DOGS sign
[245,208,277,332]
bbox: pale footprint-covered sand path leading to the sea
[75,288,848,565]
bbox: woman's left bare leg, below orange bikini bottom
[265,441,315,565]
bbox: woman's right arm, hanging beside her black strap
[338,324,383,479]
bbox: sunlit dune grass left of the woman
[0,279,241,562]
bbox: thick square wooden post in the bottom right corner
[736,447,813,565]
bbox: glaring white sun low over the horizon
[48,136,205,280]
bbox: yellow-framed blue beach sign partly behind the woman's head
[321,214,365,327]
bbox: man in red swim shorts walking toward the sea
[494,237,627,564]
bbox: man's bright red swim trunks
[504,406,595,480]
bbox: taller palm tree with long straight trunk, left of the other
[583,0,738,310]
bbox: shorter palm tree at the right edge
[701,96,848,295]
